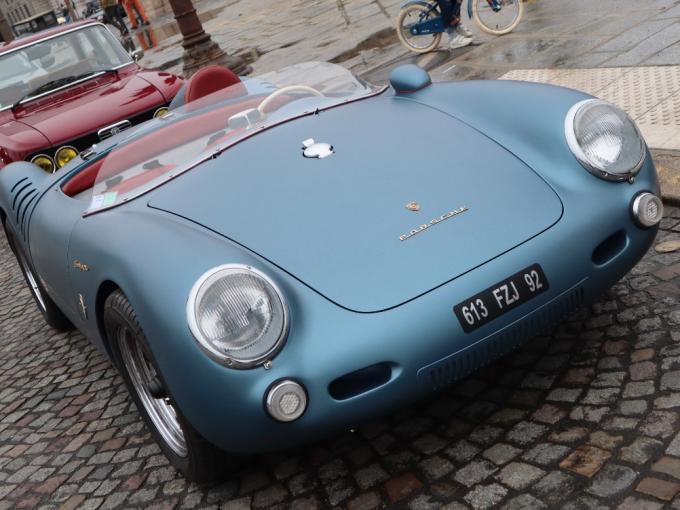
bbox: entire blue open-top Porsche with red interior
[0,63,663,480]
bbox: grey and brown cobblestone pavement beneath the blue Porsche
[0,209,680,510]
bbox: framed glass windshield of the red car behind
[0,25,131,109]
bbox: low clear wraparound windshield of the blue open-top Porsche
[79,63,381,213]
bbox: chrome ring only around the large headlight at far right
[564,98,647,182]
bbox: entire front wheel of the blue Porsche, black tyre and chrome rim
[104,290,238,482]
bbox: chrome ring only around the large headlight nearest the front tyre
[187,264,289,370]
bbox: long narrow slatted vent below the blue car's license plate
[418,285,584,390]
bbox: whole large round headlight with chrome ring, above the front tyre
[187,264,288,368]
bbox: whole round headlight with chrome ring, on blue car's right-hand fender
[565,99,645,181]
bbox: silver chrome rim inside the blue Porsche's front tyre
[117,326,187,457]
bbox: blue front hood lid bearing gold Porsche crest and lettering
[149,96,562,312]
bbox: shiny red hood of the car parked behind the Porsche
[15,68,166,146]
